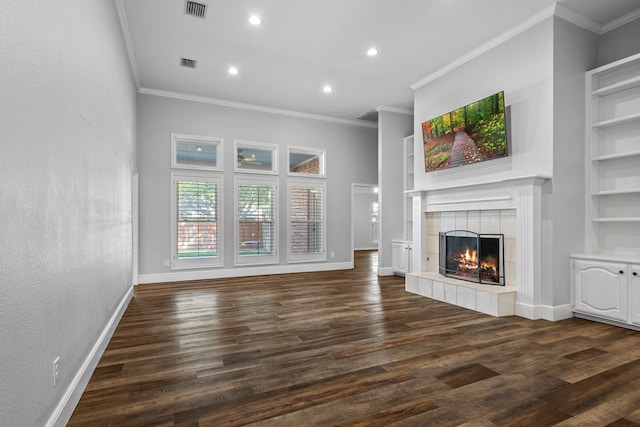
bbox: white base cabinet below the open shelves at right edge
[571,257,640,326]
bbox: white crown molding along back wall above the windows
[138,87,378,129]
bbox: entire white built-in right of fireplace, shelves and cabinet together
[571,54,640,327]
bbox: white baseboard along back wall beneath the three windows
[138,262,353,284]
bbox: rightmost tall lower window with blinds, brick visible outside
[288,181,327,262]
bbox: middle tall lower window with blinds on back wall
[236,178,278,265]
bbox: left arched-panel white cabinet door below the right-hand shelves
[574,260,628,322]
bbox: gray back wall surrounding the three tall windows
[138,95,377,283]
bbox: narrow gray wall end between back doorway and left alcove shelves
[378,110,413,275]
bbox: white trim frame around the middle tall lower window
[233,176,280,266]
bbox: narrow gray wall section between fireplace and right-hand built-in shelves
[542,17,598,306]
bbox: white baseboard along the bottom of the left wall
[45,286,133,427]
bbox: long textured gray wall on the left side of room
[0,0,136,426]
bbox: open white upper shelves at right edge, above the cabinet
[585,54,640,257]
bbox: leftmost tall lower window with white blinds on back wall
[171,174,222,269]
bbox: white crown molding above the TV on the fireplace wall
[409,4,556,91]
